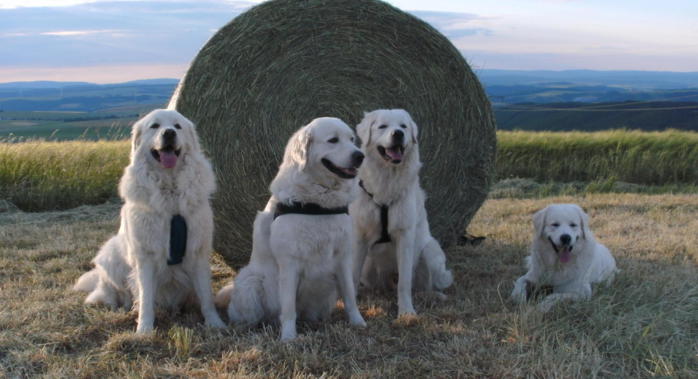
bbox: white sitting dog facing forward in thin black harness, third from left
[350,109,453,316]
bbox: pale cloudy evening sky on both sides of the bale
[0,0,698,83]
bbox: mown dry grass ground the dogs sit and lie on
[0,194,698,378]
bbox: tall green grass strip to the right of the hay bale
[497,130,698,185]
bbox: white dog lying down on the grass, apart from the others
[511,204,618,311]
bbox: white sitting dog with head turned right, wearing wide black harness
[216,117,366,340]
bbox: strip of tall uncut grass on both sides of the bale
[0,131,698,210]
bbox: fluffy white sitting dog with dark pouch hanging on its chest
[74,110,225,333]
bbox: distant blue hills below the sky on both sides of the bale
[0,70,698,139]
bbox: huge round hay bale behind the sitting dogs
[171,0,496,266]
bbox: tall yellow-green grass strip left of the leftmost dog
[0,141,129,211]
